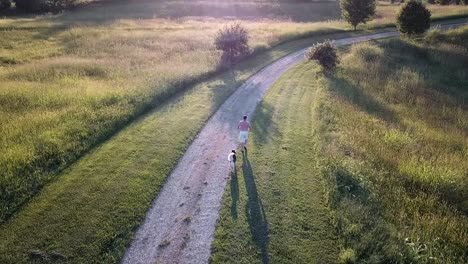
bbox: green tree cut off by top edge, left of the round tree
[340,0,376,30]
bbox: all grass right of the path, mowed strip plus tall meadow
[212,27,468,263]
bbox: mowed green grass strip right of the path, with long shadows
[210,63,339,264]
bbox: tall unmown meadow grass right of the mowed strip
[310,27,468,264]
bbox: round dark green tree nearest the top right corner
[396,0,431,36]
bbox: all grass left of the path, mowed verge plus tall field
[0,0,466,263]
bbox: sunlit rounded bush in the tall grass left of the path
[215,24,250,65]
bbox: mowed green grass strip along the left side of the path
[0,31,362,263]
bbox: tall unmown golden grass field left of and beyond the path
[0,1,468,222]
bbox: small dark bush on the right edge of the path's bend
[307,40,339,71]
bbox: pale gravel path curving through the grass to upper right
[122,23,467,264]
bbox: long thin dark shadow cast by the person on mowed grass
[242,152,270,264]
